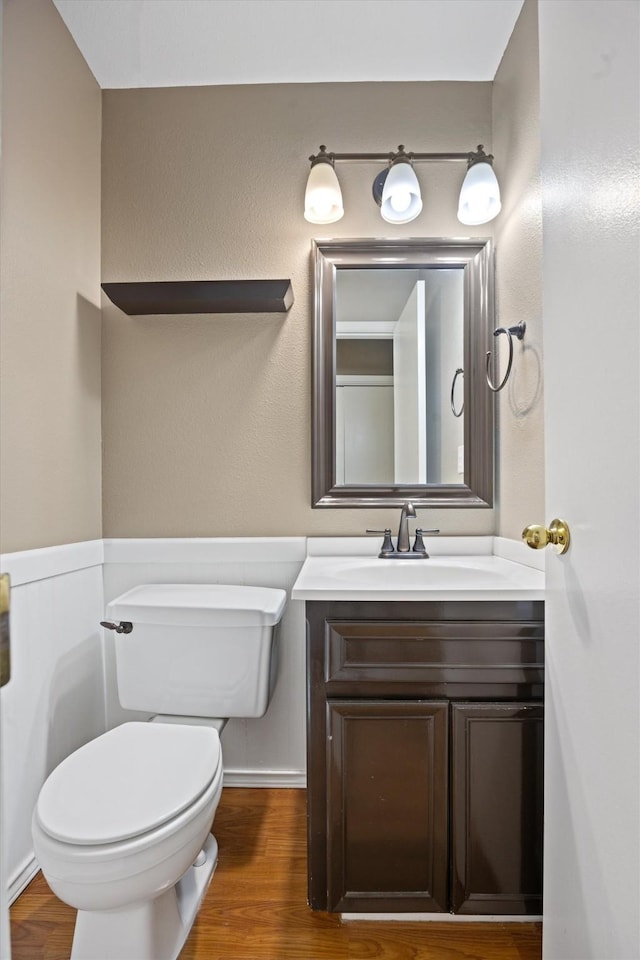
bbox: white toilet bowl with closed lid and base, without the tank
[32,723,222,960]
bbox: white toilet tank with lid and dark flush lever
[107,583,286,717]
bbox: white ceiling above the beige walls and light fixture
[54,0,523,88]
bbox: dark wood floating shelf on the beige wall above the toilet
[102,280,293,316]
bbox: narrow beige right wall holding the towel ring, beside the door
[493,0,550,539]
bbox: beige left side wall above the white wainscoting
[0,0,102,552]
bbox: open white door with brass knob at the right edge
[531,0,640,960]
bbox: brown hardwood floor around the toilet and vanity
[11,788,541,960]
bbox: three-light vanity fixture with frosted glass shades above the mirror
[304,144,500,226]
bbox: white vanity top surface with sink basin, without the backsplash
[292,556,544,600]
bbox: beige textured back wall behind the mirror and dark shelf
[102,83,494,537]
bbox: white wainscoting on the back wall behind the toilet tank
[104,537,306,787]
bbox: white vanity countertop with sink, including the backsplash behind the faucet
[291,537,545,601]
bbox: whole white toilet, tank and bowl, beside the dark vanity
[32,584,286,960]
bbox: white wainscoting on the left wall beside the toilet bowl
[0,540,106,900]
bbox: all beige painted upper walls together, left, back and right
[0,0,544,551]
